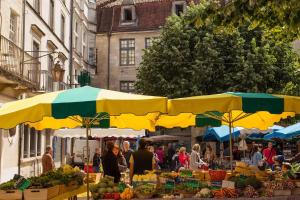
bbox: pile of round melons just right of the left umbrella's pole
[90,176,120,200]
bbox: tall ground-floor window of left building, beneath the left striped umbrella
[22,125,42,158]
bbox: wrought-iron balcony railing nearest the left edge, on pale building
[0,35,40,86]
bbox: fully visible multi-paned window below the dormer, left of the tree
[120,39,135,65]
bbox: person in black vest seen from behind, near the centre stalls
[129,139,155,180]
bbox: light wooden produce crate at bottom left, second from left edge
[24,185,59,200]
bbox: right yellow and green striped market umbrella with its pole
[165,93,300,170]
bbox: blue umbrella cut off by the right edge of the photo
[264,123,300,139]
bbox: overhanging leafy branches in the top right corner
[194,0,300,41]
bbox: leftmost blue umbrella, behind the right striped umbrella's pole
[203,125,243,142]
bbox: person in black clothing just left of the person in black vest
[102,142,121,183]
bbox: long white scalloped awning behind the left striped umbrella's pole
[54,128,145,138]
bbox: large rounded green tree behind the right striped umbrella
[136,2,298,98]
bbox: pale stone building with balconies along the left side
[0,0,96,183]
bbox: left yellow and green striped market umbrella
[0,86,167,130]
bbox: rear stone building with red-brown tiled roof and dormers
[93,0,199,92]
